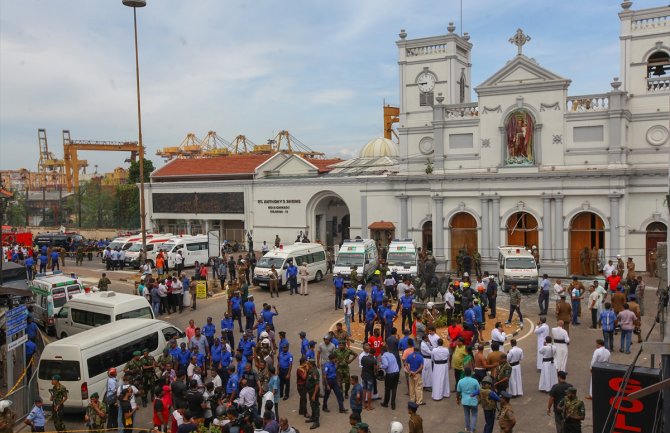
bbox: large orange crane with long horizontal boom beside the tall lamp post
[63,129,140,191]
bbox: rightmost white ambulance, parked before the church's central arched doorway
[498,245,539,293]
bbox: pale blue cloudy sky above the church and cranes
[0,0,665,170]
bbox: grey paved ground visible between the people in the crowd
[11,261,658,433]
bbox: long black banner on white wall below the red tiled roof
[151,192,244,214]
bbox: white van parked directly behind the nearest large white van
[55,291,155,338]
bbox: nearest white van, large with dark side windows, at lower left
[37,319,186,411]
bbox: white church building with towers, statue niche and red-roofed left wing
[146,2,670,275]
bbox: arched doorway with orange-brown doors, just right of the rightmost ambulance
[569,212,616,275]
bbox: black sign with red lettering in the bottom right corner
[592,363,663,433]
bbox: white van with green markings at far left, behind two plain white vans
[29,271,84,335]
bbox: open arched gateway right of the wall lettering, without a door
[307,191,351,248]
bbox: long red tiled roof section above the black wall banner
[151,154,272,178]
